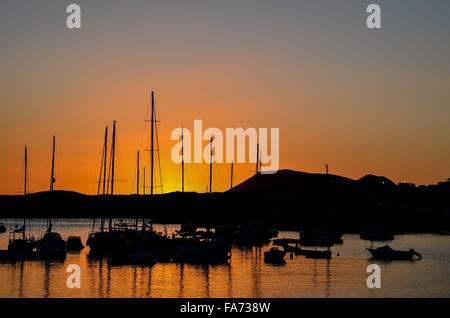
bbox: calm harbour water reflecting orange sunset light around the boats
[0,219,450,298]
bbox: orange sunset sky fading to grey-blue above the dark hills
[0,0,450,194]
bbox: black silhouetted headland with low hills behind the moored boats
[0,170,450,233]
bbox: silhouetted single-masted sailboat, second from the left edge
[37,136,66,259]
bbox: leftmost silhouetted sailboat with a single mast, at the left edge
[0,145,37,261]
